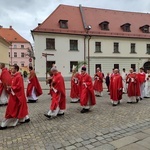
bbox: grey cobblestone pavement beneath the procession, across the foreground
[0,81,150,150]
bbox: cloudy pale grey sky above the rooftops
[0,0,150,43]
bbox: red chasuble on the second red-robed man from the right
[126,73,141,97]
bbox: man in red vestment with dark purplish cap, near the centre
[80,66,96,113]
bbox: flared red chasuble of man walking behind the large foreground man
[27,70,42,96]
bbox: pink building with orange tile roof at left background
[0,26,32,66]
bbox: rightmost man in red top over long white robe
[138,67,146,100]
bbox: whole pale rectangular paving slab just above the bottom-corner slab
[110,136,138,148]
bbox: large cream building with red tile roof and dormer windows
[31,5,150,77]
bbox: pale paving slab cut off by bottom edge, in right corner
[117,143,149,150]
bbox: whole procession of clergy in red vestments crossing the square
[0,63,150,130]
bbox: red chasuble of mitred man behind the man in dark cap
[70,73,80,98]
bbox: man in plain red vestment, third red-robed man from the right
[109,69,123,106]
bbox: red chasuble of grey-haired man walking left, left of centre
[50,72,66,110]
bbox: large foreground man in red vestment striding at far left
[0,65,30,130]
